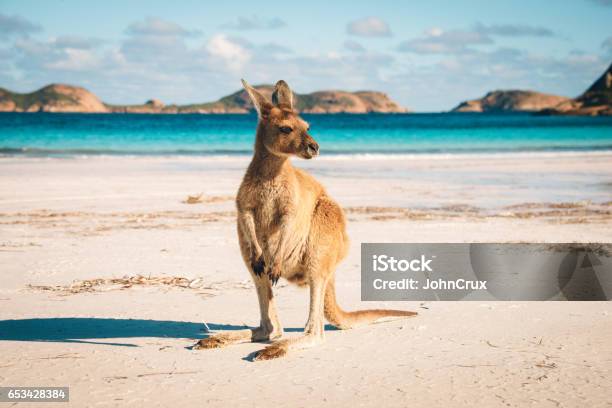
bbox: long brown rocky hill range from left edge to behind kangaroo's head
[0,84,407,113]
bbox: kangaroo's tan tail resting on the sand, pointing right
[325,276,417,329]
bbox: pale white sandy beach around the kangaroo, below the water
[0,153,612,407]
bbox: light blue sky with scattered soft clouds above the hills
[0,0,612,111]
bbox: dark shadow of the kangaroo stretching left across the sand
[0,317,320,347]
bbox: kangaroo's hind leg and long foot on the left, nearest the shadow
[193,272,283,350]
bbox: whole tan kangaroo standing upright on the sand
[194,80,416,360]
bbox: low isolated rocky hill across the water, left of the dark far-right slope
[452,90,570,112]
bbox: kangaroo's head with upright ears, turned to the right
[242,79,319,159]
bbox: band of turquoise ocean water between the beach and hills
[0,113,612,157]
